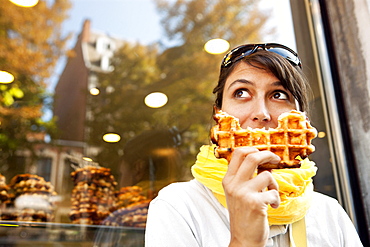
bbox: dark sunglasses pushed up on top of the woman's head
[221,43,302,68]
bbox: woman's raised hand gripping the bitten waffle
[222,147,280,246]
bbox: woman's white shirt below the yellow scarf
[145,179,362,247]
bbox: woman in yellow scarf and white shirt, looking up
[146,44,362,246]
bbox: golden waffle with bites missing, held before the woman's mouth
[211,110,317,169]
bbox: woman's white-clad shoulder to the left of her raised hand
[146,180,229,246]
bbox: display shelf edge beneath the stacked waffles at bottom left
[0,221,145,247]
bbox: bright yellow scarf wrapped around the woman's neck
[191,145,317,225]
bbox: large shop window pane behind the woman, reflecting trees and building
[0,0,334,243]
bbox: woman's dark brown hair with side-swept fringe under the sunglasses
[213,50,311,112]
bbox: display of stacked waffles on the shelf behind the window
[0,165,150,246]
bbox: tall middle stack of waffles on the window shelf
[69,165,117,225]
